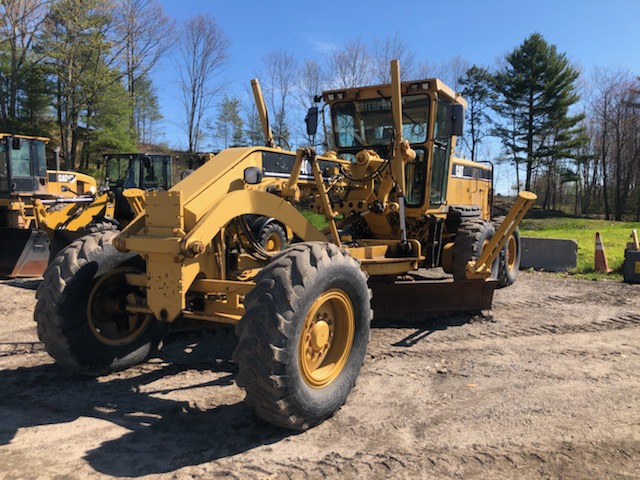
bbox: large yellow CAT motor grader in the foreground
[35,61,535,430]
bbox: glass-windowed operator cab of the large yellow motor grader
[323,79,466,212]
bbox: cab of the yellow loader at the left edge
[0,133,48,197]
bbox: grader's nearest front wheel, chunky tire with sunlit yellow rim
[233,243,372,430]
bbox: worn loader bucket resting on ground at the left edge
[0,227,49,277]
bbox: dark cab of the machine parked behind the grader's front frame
[103,153,171,220]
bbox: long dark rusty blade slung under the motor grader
[370,277,498,318]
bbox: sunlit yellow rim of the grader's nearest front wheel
[299,289,355,388]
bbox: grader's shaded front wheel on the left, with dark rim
[34,231,170,376]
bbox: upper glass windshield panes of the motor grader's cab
[333,95,429,148]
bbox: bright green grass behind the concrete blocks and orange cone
[520,217,640,279]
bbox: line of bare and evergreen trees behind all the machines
[0,0,640,219]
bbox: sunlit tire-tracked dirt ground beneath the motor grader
[0,272,640,479]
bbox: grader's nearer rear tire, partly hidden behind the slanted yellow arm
[452,218,500,281]
